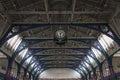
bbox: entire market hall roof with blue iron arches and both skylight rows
[0,0,120,79]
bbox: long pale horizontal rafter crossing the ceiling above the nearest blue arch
[7,11,111,15]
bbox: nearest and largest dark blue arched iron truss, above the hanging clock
[1,23,120,45]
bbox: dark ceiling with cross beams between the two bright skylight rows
[0,0,117,78]
